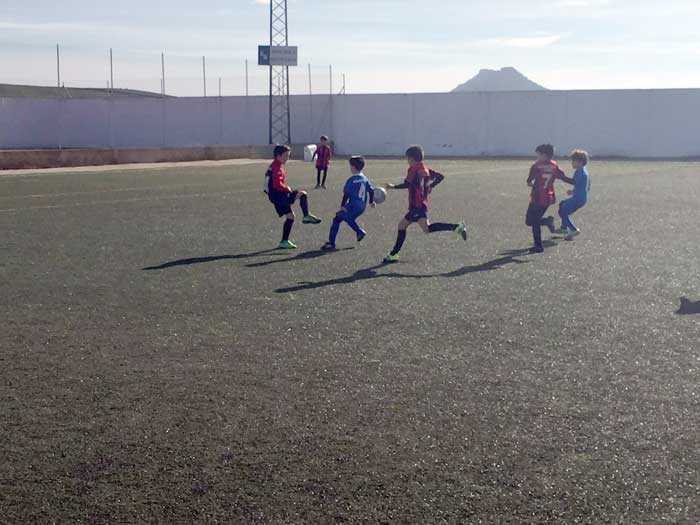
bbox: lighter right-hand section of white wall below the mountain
[333,90,700,157]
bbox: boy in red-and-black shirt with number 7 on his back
[525,144,574,253]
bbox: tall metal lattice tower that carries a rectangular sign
[270,0,292,144]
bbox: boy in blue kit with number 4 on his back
[321,157,375,251]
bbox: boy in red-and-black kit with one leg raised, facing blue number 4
[263,146,321,250]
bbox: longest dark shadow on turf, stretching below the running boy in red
[275,255,529,293]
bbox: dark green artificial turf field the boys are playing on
[0,160,700,524]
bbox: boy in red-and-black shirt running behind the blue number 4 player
[384,146,467,264]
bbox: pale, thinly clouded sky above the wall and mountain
[0,0,700,96]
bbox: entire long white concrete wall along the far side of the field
[0,90,700,157]
